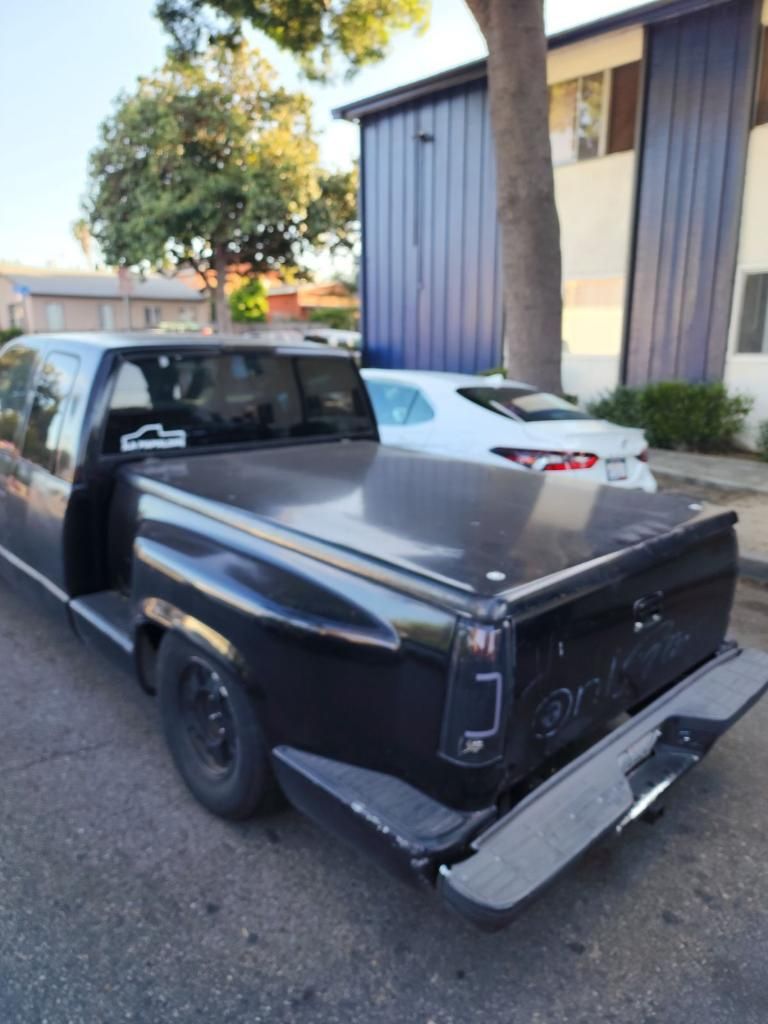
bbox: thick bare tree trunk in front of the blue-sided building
[467,0,562,392]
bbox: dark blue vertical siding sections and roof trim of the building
[337,0,761,391]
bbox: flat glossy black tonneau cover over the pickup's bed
[127,441,735,597]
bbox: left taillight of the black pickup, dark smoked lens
[440,623,511,767]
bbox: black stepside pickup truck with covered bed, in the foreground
[0,335,768,927]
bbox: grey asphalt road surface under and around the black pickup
[0,586,768,1024]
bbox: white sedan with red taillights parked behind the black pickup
[362,370,656,492]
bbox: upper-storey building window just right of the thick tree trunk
[549,61,640,167]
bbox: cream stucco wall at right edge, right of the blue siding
[725,121,768,443]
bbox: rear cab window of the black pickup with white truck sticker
[104,352,373,455]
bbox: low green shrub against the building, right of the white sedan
[588,381,754,452]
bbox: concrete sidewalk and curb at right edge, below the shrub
[650,449,768,583]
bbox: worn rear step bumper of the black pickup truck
[438,648,768,928]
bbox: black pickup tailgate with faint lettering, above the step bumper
[504,513,737,784]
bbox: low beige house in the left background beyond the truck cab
[0,264,210,333]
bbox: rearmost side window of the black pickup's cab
[23,352,80,472]
